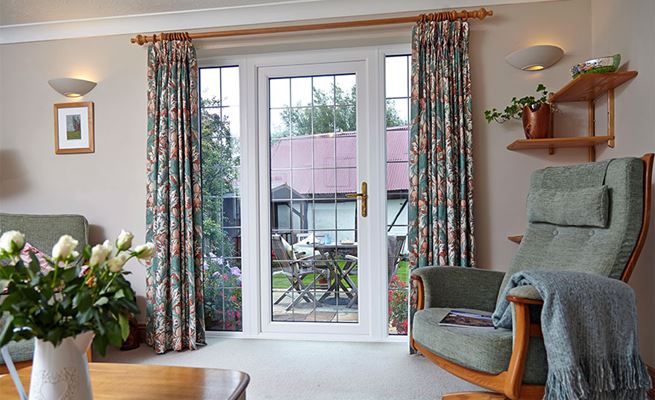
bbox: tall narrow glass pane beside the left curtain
[200,67,242,331]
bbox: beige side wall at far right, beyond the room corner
[591,0,655,365]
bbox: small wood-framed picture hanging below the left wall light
[55,101,95,154]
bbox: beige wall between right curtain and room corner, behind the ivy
[471,0,591,269]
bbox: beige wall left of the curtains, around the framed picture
[0,36,147,312]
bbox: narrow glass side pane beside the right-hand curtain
[385,55,411,335]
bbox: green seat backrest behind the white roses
[0,213,89,255]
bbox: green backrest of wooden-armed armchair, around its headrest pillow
[501,158,644,304]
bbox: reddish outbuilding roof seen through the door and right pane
[271,128,409,195]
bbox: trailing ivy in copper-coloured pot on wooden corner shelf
[484,83,552,139]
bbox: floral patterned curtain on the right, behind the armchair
[408,18,475,350]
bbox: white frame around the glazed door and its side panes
[200,44,410,342]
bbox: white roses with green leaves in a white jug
[0,231,155,400]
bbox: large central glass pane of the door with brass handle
[268,74,359,323]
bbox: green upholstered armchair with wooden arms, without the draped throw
[410,154,653,399]
